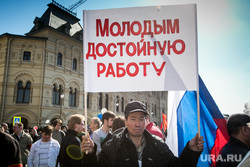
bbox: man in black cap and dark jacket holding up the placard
[81,101,204,167]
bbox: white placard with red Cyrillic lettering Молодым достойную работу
[83,4,198,92]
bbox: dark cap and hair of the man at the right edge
[227,114,250,136]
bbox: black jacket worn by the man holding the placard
[83,128,201,167]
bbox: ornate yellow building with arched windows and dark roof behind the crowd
[0,2,168,128]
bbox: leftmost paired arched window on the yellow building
[17,81,31,103]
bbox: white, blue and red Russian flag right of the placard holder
[166,77,229,167]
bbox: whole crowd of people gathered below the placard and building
[0,101,250,167]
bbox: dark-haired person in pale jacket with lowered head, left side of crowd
[28,125,60,167]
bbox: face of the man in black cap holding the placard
[125,112,146,137]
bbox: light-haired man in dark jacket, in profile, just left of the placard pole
[58,114,94,167]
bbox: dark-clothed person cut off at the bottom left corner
[0,131,23,167]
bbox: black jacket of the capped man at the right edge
[216,137,250,167]
